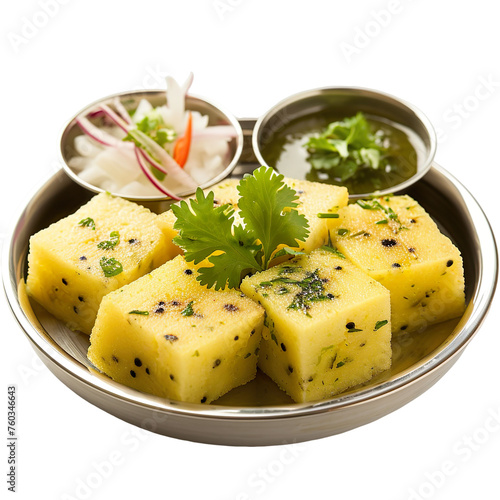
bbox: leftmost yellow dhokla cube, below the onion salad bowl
[26,193,170,334]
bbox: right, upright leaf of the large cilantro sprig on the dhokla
[238,167,309,269]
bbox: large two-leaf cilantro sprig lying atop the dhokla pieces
[172,167,309,290]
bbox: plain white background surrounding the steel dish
[0,0,500,500]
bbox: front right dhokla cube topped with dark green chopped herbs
[241,250,391,402]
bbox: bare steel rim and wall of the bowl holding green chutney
[252,87,437,198]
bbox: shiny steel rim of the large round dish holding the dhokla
[2,162,498,421]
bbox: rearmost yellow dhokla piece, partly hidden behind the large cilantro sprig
[158,178,349,253]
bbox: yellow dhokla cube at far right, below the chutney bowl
[331,196,465,333]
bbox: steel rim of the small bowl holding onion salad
[59,90,243,212]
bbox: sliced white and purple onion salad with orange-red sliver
[68,74,236,200]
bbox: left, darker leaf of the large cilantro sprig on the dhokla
[172,188,263,290]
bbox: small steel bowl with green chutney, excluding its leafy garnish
[252,87,437,198]
